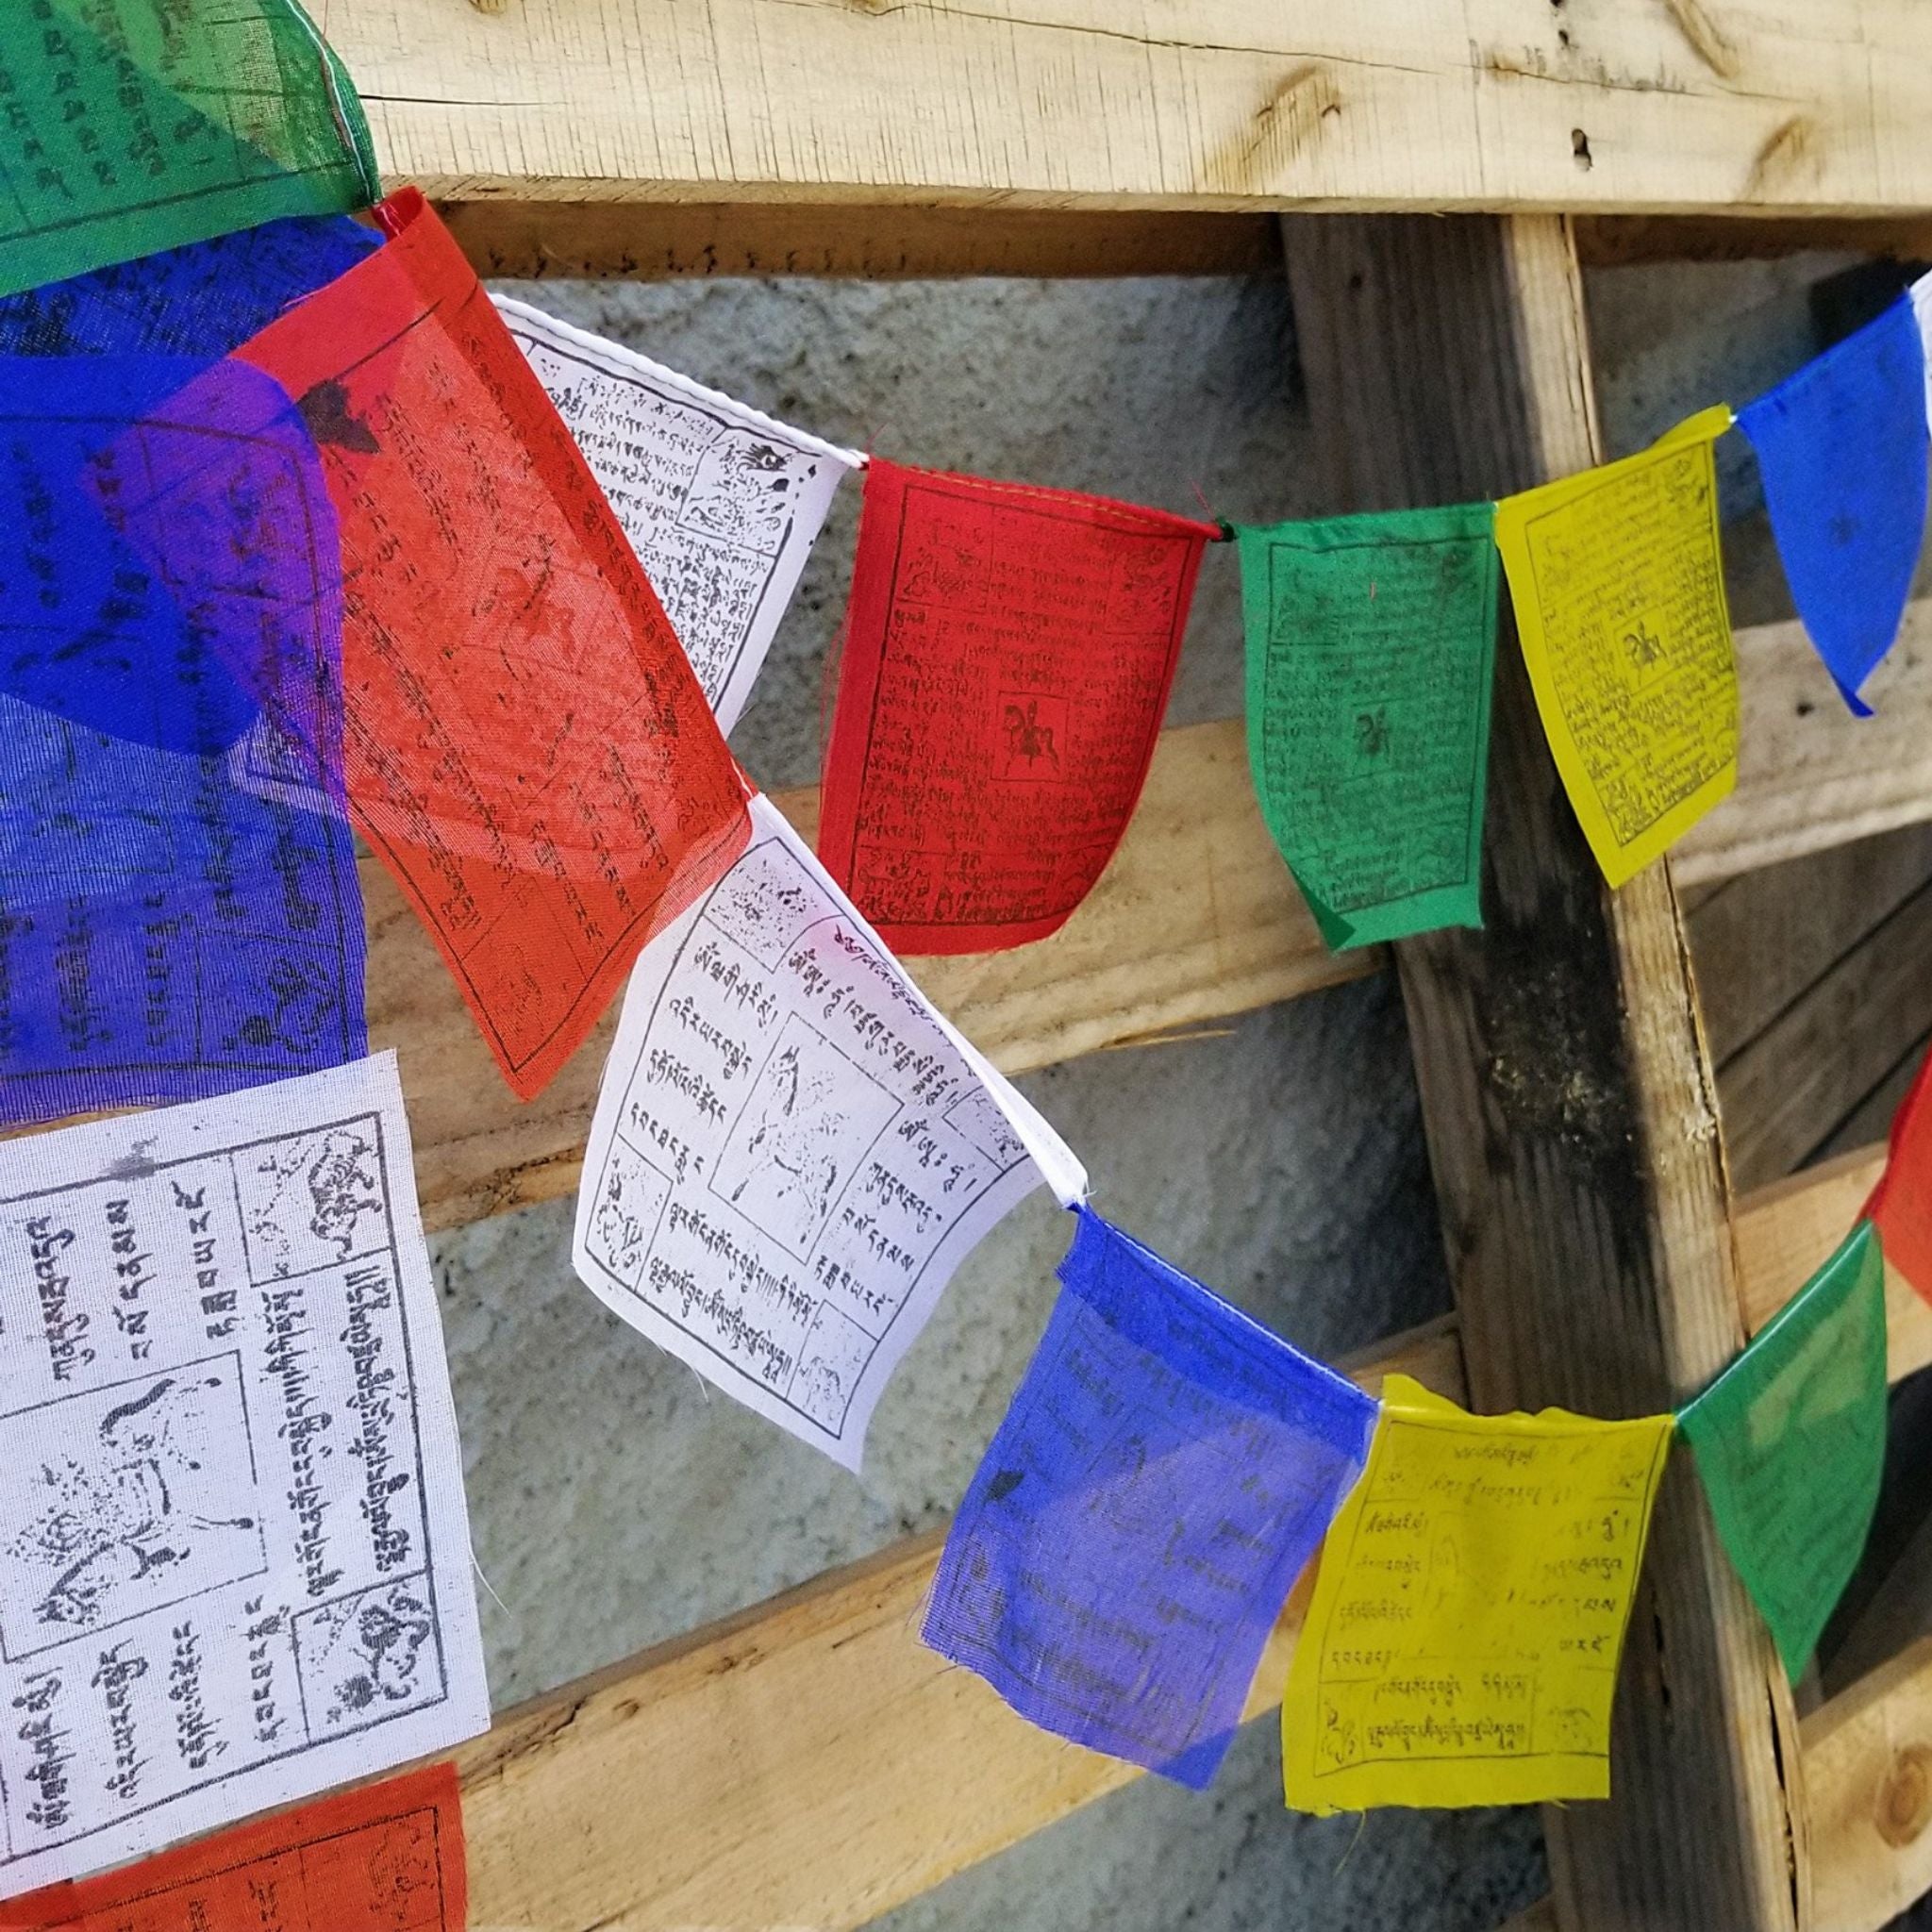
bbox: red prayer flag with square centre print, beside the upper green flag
[819,459,1219,953]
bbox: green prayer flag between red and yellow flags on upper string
[1235,502,1497,949]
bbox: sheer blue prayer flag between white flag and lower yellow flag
[922,1208,1375,1789]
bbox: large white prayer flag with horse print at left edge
[0,1053,489,1895]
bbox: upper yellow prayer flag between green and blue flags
[1495,404,1737,885]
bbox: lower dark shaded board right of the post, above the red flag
[1718,885,1932,1189]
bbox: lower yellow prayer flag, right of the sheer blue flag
[1281,1375,1672,1816]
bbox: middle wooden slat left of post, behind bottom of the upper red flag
[380,721,1379,1229]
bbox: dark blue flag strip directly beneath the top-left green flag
[0,214,380,361]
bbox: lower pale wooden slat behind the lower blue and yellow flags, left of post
[458,1324,1460,1932]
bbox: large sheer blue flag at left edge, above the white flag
[0,356,367,1123]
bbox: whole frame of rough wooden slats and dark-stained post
[297,0,1932,1932]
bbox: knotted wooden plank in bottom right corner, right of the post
[1803,1637,1932,1932]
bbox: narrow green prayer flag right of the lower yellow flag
[1677,1221,1886,1683]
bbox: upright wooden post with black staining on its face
[1285,216,1808,1932]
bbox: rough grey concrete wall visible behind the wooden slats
[435,249,1846,1932]
